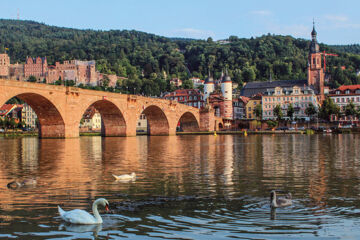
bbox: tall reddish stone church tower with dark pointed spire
[308,23,325,100]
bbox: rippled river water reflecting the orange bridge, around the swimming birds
[0,134,360,240]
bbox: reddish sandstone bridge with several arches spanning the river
[0,79,219,138]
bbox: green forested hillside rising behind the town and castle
[0,20,360,95]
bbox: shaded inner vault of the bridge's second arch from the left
[79,100,126,137]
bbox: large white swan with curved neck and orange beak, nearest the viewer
[58,198,109,224]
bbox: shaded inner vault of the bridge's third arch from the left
[142,105,169,135]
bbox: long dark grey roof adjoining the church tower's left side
[240,80,307,97]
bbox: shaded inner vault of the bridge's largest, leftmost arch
[10,92,65,138]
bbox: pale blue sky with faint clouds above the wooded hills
[0,0,360,44]
